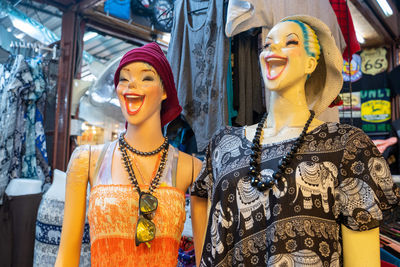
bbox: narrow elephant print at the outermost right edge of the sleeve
[368,158,397,204]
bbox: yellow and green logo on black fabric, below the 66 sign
[361,100,391,123]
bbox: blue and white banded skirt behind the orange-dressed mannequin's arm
[33,197,90,267]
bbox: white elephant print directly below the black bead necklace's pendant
[236,169,287,230]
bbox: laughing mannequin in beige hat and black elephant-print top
[192,15,399,266]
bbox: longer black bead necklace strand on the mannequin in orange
[118,133,168,195]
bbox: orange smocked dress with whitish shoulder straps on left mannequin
[88,142,186,267]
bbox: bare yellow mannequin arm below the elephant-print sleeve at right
[341,225,381,267]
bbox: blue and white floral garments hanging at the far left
[0,56,50,204]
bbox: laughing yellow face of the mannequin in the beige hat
[260,21,317,91]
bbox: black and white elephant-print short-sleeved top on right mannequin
[191,123,400,267]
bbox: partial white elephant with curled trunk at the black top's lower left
[211,201,233,257]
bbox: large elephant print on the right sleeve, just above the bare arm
[335,178,382,229]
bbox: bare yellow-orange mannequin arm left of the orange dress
[55,147,89,267]
